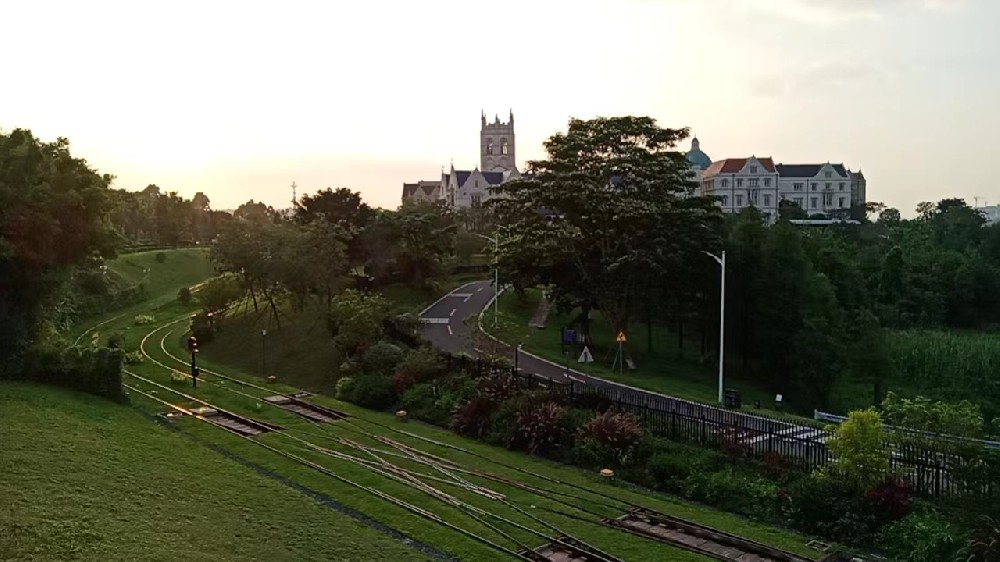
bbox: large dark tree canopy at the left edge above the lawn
[0,129,112,357]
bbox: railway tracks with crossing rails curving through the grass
[126,310,840,562]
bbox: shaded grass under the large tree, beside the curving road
[483,289,804,415]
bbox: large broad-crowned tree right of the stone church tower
[488,117,721,350]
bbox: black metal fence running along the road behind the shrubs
[443,348,1000,497]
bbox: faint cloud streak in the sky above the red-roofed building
[749,60,902,98]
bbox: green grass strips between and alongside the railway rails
[125,308,815,561]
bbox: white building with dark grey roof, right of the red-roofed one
[777,162,852,216]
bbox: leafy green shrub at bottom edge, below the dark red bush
[878,512,969,562]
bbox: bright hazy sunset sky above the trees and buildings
[0,0,1000,213]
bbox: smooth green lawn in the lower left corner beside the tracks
[0,383,432,561]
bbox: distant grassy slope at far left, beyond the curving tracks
[67,248,215,339]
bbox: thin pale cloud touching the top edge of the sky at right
[738,0,968,24]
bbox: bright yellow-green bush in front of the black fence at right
[825,408,890,488]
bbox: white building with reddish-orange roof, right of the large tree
[689,156,779,222]
